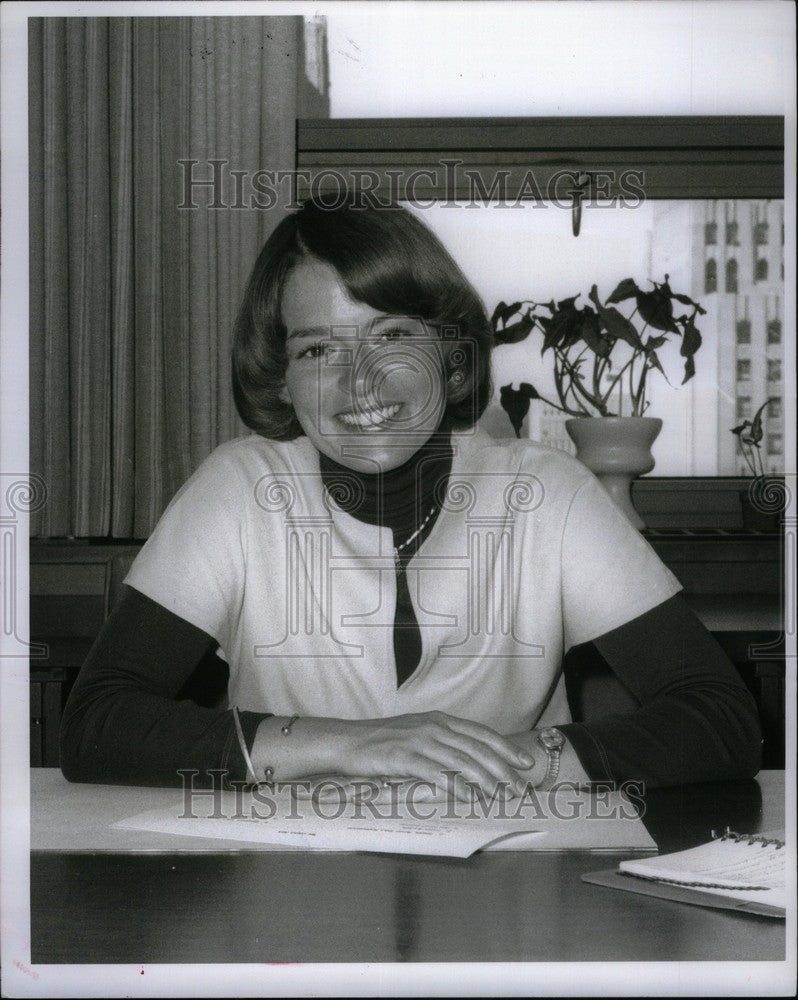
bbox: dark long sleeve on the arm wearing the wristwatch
[558,594,761,787]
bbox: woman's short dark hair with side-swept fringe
[233,201,493,441]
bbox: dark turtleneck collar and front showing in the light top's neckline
[319,428,452,687]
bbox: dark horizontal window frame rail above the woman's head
[296,115,784,200]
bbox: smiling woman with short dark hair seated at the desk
[57,203,760,797]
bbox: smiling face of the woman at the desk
[282,258,446,473]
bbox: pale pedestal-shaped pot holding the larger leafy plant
[565,417,662,528]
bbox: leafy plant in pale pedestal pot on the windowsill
[492,274,705,528]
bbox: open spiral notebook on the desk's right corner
[582,829,787,917]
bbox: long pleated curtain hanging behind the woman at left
[29,17,324,538]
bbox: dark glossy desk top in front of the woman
[31,769,785,964]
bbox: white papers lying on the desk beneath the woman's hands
[113,789,654,858]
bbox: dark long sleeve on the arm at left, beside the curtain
[61,587,268,785]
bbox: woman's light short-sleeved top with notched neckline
[125,431,681,733]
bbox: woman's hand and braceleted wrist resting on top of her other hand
[252,712,534,801]
